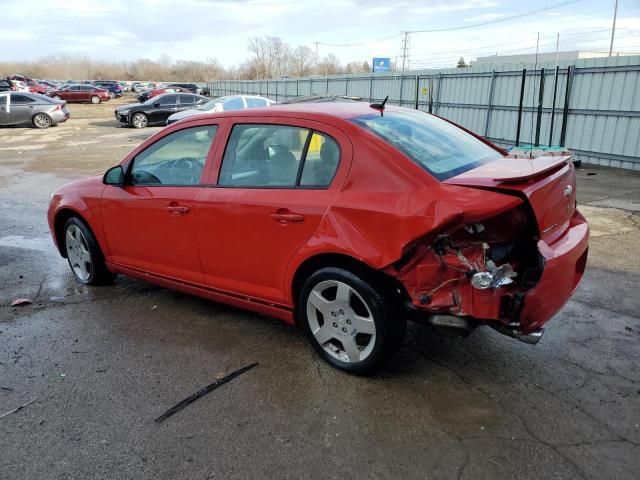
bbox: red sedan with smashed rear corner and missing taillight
[48,103,589,373]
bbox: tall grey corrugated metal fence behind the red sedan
[208,56,640,170]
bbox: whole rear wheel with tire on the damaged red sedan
[298,268,406,374]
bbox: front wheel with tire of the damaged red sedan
[63,217,114,285]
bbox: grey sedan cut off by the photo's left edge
[0,92,71,128]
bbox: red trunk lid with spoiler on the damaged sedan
[444,155,576,243]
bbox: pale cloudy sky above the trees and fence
[0,0,640,68]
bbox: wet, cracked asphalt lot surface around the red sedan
[0,94,640,480]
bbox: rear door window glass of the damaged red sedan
[218,124,340,188]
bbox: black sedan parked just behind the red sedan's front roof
[114,93,209,128]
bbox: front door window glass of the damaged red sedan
[128,125,218,186]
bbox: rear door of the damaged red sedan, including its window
[198,117,352,302]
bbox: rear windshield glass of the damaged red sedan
[351,110,502,181]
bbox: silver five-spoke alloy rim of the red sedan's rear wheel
[307,280,376,363]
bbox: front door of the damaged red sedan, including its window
[102,125,217,283]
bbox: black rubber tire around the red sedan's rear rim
[297,267,407,375]
